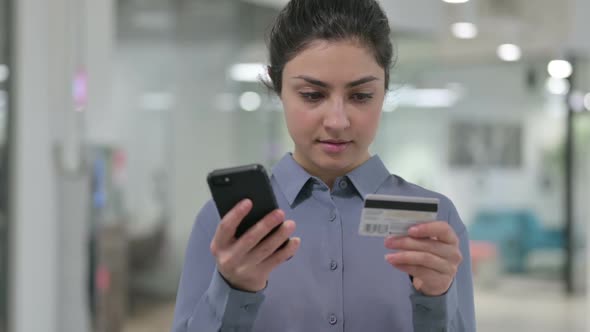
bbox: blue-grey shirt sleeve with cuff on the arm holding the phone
[172,201,264,332]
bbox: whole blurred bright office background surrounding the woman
[0,0,590,332]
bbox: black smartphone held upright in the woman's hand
[207,164,289,249]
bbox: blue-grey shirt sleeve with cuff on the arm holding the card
[410,198,476,332]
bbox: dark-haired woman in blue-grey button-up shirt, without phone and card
[173,0,475,332]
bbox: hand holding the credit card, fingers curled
[385,221,463,296]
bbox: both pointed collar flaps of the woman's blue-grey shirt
[272,153,391,206]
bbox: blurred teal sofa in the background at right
[469,209,565,273]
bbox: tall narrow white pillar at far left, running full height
[10,0,58,332]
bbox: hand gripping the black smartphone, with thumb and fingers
[211,199,301,292]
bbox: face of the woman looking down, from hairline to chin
[281,40,385,185]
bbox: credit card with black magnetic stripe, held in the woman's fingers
[359,194,439,237]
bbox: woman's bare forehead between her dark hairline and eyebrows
[284,40,385,82]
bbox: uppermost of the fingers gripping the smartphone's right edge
[231,210,285,257]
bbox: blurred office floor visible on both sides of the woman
[125,278,588,332]
